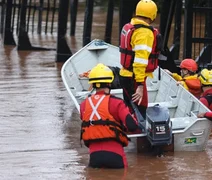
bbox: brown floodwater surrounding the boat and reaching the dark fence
[0,1,212,180]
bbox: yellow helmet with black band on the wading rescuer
[89,63,114,84]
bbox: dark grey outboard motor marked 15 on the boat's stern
[146,104,172,146]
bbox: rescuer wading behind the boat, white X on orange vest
[80,63,138,168]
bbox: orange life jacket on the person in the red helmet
[185,79,202,98]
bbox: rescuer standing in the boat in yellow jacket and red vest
[120,0,162,119]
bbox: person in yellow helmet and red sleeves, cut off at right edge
[198,69,212,120]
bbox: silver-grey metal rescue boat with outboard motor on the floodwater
[61,39,212,151]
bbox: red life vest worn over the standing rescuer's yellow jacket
[119,23,162,72]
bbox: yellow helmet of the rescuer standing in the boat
[135,0,158,21]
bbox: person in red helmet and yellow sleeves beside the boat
[165,59,202,98]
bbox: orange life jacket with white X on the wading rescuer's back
[81,94,129,147]
